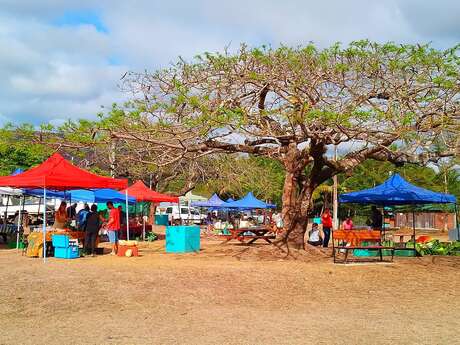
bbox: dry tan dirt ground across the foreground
[0,240,460,345]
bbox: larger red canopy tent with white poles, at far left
[0,153,129,260]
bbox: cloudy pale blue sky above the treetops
[0,0,460,124]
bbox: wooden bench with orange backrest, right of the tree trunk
[332,230,395,263]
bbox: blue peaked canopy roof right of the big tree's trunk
[339,174,456,205]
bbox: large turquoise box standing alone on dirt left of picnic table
[166,225,200,253]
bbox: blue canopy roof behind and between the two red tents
[24,189,136,204]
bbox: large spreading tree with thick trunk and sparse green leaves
[60,41,460,244]
